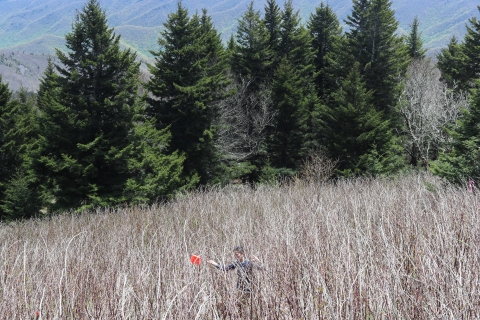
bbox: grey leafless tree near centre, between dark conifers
[215,79,275,161]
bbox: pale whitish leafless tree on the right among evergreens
[398,59,468,166]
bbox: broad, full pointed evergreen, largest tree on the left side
[37,0,147,210]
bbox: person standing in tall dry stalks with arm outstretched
[207,246,264,293]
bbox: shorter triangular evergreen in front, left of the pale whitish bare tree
[327,64,402,176]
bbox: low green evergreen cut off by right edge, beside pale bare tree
[430,81,480,183]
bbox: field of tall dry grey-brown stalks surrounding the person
[0,176,480,319]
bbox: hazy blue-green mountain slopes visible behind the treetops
[0,0,478,90]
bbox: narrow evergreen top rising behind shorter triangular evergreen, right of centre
[308,2,347,101]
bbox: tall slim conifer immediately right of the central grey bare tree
[267,1,320,169]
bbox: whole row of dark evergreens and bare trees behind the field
[0,0,480,220]
